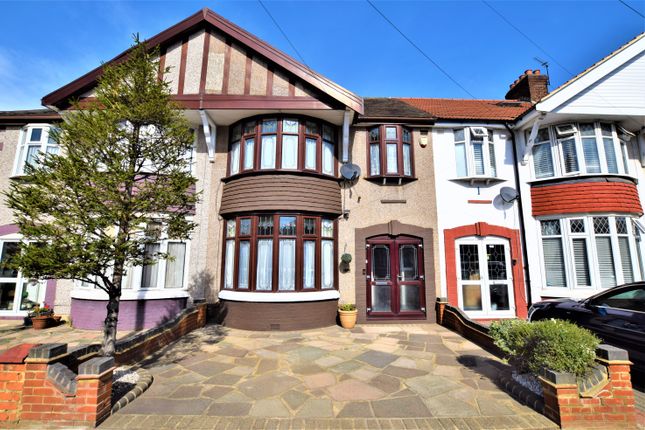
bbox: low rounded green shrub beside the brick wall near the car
[490,319,600,376]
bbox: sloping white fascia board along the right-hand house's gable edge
[535,38,645,112]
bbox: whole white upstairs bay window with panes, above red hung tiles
[532,122,630,179]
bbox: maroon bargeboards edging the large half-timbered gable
[42,8,363,113]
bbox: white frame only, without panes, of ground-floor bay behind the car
[536,213,643,297]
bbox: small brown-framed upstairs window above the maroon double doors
[368,125,414,178]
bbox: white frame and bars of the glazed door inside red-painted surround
[455,236,517,318]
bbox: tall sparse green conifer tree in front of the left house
[6,38,198,352]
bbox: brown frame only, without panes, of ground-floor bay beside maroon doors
[220,212,338,293]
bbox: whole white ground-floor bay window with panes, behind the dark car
[540,215,642,293]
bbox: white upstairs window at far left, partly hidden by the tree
[13,124,59,176]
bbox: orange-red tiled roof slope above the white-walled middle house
[399,98,533,121]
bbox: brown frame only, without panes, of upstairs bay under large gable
[226,114,339,178]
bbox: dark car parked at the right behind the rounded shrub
[529,282,645,373]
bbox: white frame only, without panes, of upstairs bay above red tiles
[530,121,634,180]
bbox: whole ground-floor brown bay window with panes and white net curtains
[222,213,337,292]
